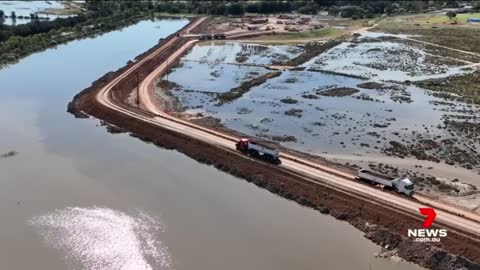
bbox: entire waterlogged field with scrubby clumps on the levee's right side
[164,37,480,190]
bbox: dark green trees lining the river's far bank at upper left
[0,2,154,67]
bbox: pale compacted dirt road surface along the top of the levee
[96,18,480,241]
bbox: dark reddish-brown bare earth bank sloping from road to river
[68,17,480,269]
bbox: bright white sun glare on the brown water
[30,207,171,270]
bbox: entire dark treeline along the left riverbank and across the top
[0,0,480,65]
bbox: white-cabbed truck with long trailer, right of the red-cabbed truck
[356,169,414,197]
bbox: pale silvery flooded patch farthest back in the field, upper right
[304,32,471,82]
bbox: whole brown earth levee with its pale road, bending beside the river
[69,18,480,269]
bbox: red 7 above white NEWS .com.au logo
[408,208,447,242]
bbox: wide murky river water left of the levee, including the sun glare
[0,19,419,270]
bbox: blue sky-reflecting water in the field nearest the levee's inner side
[169,52,480,154]
